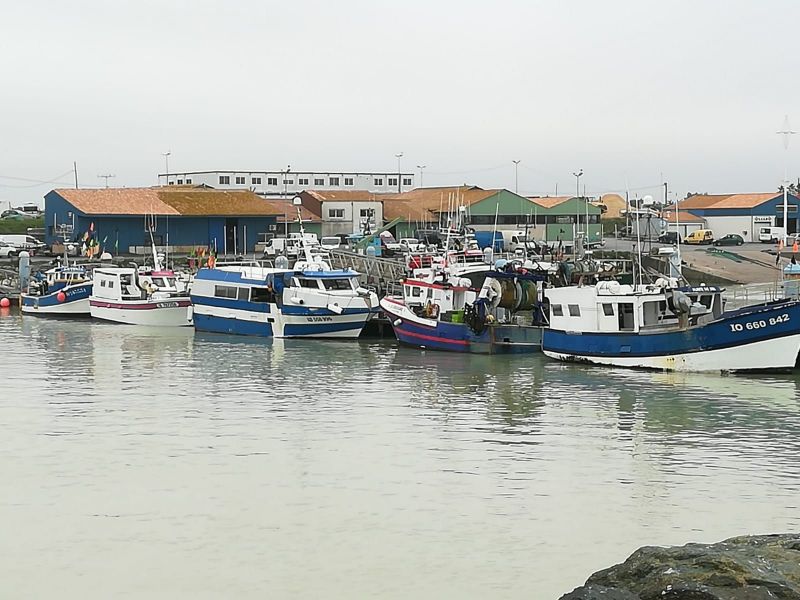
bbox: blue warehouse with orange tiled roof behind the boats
[45,186,290,254]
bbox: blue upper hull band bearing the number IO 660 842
[542,302,800,357]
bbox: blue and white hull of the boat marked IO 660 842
[542,302,800,372]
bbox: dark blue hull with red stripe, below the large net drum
[381,298,542,354]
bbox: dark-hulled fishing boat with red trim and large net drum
[381,261,551,354]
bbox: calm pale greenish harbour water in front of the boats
[0,312,800,599]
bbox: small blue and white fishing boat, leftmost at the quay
[20,264,92,316]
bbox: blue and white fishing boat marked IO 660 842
[542,278,800,372]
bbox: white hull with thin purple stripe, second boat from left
[89,298,192,327]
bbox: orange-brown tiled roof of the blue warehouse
[54,186,282,217]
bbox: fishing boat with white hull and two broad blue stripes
[191,206,379,338]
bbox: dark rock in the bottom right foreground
[561,534,800,600]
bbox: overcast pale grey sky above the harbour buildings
[0,0,800,203]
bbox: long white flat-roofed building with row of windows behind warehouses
[158,168,414,199]
